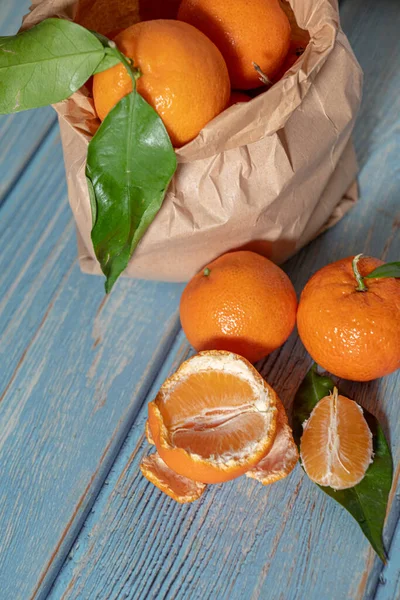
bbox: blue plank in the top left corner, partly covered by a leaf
[0,0,57,205]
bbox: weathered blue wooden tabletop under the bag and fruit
[0,0,400,600]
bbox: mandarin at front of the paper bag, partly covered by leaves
[93,19,230,147]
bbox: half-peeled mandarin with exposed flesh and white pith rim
[149,351,277,483]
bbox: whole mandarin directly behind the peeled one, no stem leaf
[180,251,297,362]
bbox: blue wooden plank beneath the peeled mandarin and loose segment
[50,0,400,600]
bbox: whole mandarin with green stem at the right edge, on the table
[297,257,400,381]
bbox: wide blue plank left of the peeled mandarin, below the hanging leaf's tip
[0,130,181,600]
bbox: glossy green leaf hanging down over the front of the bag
[86,88,176,293]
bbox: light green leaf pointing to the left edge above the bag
[0,19,109,114]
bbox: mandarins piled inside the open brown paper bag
[79,0,309,148]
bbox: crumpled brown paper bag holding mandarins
[23,0,362,281]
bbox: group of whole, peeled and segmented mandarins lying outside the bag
[141,251,400,502]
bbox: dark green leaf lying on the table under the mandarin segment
[293,365,393,562]
